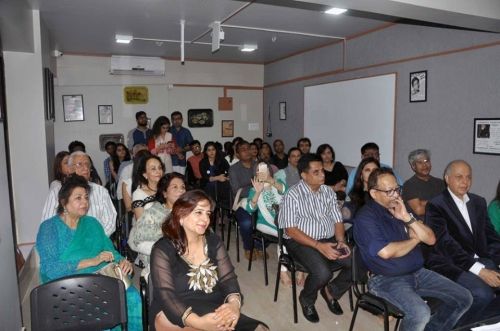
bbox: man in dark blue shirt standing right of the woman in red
[170,111,193,175]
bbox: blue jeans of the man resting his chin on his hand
[368,268,472,331]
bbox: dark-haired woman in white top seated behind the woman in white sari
[132,155,165,220]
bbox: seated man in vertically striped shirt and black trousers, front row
[278,154,351,323]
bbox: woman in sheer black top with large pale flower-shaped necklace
[150,190,267,331]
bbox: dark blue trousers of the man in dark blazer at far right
[457,259,500,325]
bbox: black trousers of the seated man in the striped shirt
[285,237,351,305]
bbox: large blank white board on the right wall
[304,74,396,167]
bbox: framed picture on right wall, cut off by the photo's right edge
[473,118,500,155]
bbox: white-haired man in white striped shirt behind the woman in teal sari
[42,151,116,237]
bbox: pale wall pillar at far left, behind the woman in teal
[3,11,48,244]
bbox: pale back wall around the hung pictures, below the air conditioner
[54,55,264,176]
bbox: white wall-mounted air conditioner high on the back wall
[110,55,165,76]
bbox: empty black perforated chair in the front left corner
[30,274,127,331]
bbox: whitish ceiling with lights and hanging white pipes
[0,0,500,63]
